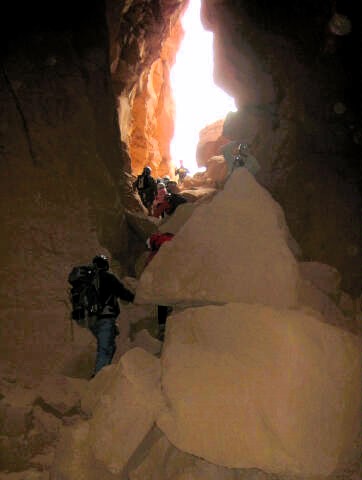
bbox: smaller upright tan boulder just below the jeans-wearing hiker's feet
[89,348,162,474]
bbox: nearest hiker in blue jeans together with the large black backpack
[69,255,134,377]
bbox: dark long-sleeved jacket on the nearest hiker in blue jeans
[99,270,134,317]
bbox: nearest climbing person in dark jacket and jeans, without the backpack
[89,255,134,377]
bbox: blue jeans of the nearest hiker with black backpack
[90,317,117,374]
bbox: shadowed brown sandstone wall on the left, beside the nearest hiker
[0,1,127,375]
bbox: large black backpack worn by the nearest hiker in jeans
[68,265,103,328]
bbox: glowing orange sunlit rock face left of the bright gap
[107,0,185,176]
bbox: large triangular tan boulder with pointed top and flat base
[136,168,298,307]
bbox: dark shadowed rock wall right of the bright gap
[202,0,362,295]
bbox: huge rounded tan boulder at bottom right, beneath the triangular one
[157,304,361,478]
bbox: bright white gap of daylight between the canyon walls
[171,0,236,174]
